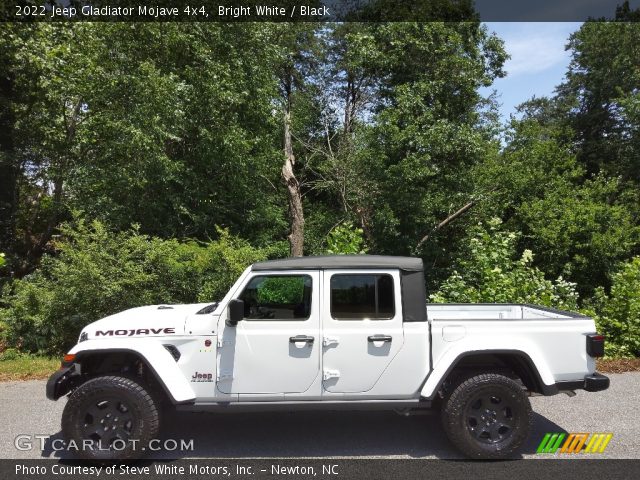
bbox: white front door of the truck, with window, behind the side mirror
[217,271,322,394]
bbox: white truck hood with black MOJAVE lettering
[80,303,211,341]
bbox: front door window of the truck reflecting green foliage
[239,275,311,320]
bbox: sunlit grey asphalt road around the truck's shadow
[0,373,640,459]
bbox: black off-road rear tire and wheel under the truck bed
[442,373,532,459]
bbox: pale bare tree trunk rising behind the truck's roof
[282,82,304,257]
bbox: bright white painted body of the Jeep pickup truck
[69,268,595,404]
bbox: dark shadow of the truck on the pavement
[42,412,565,460]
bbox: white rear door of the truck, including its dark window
[322,270,404,393]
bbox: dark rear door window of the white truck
[331,274,395,320]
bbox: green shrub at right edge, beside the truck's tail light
[590,257,640,357]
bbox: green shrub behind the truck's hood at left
[0,220,268,353]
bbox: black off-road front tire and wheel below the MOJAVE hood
[62,375,160,460]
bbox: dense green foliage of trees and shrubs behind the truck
[0,7,640,355]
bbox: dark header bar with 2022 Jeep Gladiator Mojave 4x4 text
[0,0,640,22]
